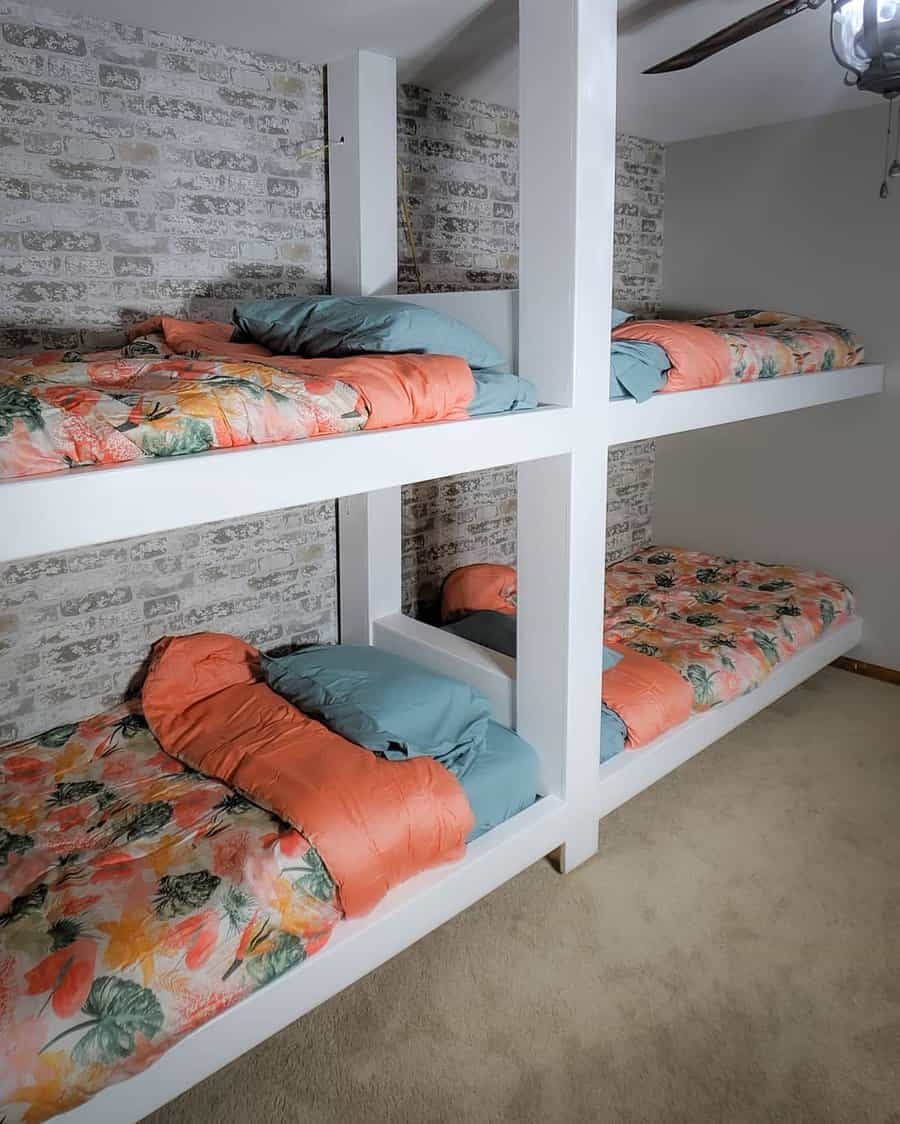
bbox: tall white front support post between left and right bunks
[517,0,616,869]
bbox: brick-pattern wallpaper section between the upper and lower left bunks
[0,502,337,742]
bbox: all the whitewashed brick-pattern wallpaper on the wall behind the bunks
[0,19,662,741]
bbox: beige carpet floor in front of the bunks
[148,669,900,1124]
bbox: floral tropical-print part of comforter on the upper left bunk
[0,334,367,479]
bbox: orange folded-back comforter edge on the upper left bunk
[128,316,475,429]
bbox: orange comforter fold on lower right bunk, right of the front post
[603,644,693,750]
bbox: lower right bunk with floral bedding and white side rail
[440,546,862,815]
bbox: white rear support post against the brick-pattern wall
[327,51,401,644]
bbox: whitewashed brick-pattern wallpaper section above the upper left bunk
[0,3,327,352]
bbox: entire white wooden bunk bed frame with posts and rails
[0,0,881,1124]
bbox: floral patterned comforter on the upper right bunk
[694,309,864,382]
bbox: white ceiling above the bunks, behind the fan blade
[43,0,875,142]
